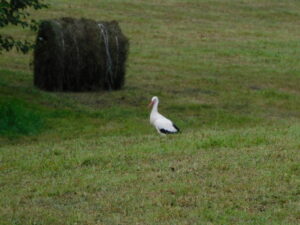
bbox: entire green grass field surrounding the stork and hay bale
[0,0,300,225]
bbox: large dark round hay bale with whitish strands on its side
[34,18,129,91]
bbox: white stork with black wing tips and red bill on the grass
[149,96,180,135]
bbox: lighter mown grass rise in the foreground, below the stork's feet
[1,125,300,224]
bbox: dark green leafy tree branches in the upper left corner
[0,0,48,53]
